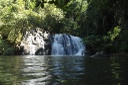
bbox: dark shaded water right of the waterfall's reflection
[84,55,128,85]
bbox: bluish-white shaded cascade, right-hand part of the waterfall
[51,34,85,56]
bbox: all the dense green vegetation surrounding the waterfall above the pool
[0,0,128,54]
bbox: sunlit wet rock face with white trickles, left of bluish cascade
[20,28,51,55]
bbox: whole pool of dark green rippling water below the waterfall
[0,55,128,85]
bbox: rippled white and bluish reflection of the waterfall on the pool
[22,56,85,85]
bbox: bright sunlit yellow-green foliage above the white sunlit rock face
[0,0,64,44]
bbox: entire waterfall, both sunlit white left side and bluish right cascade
[20,28,85,56]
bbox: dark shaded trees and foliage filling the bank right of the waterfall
[79,0,128,52]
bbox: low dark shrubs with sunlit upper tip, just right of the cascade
[84,26,121,51]
